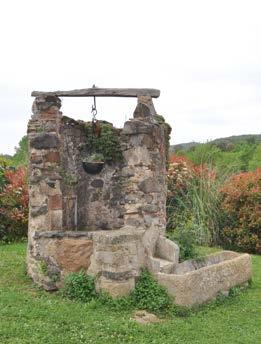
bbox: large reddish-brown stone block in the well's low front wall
[55,238,93,272]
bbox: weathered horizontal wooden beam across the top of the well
[31,87,160,98]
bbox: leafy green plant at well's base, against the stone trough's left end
[130,269,172,313]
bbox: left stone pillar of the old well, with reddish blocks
[27,96,62,288]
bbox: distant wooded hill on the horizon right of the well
[170,134,261,152]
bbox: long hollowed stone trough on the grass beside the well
[155,251,252,306]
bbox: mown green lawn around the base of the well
[0,244,261,344]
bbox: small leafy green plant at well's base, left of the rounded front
[62,271,97,302]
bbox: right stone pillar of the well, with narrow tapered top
[122,96,167,238]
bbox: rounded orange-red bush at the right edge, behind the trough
[220,168,261,254]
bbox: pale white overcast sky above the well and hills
[0,0,261,154]
